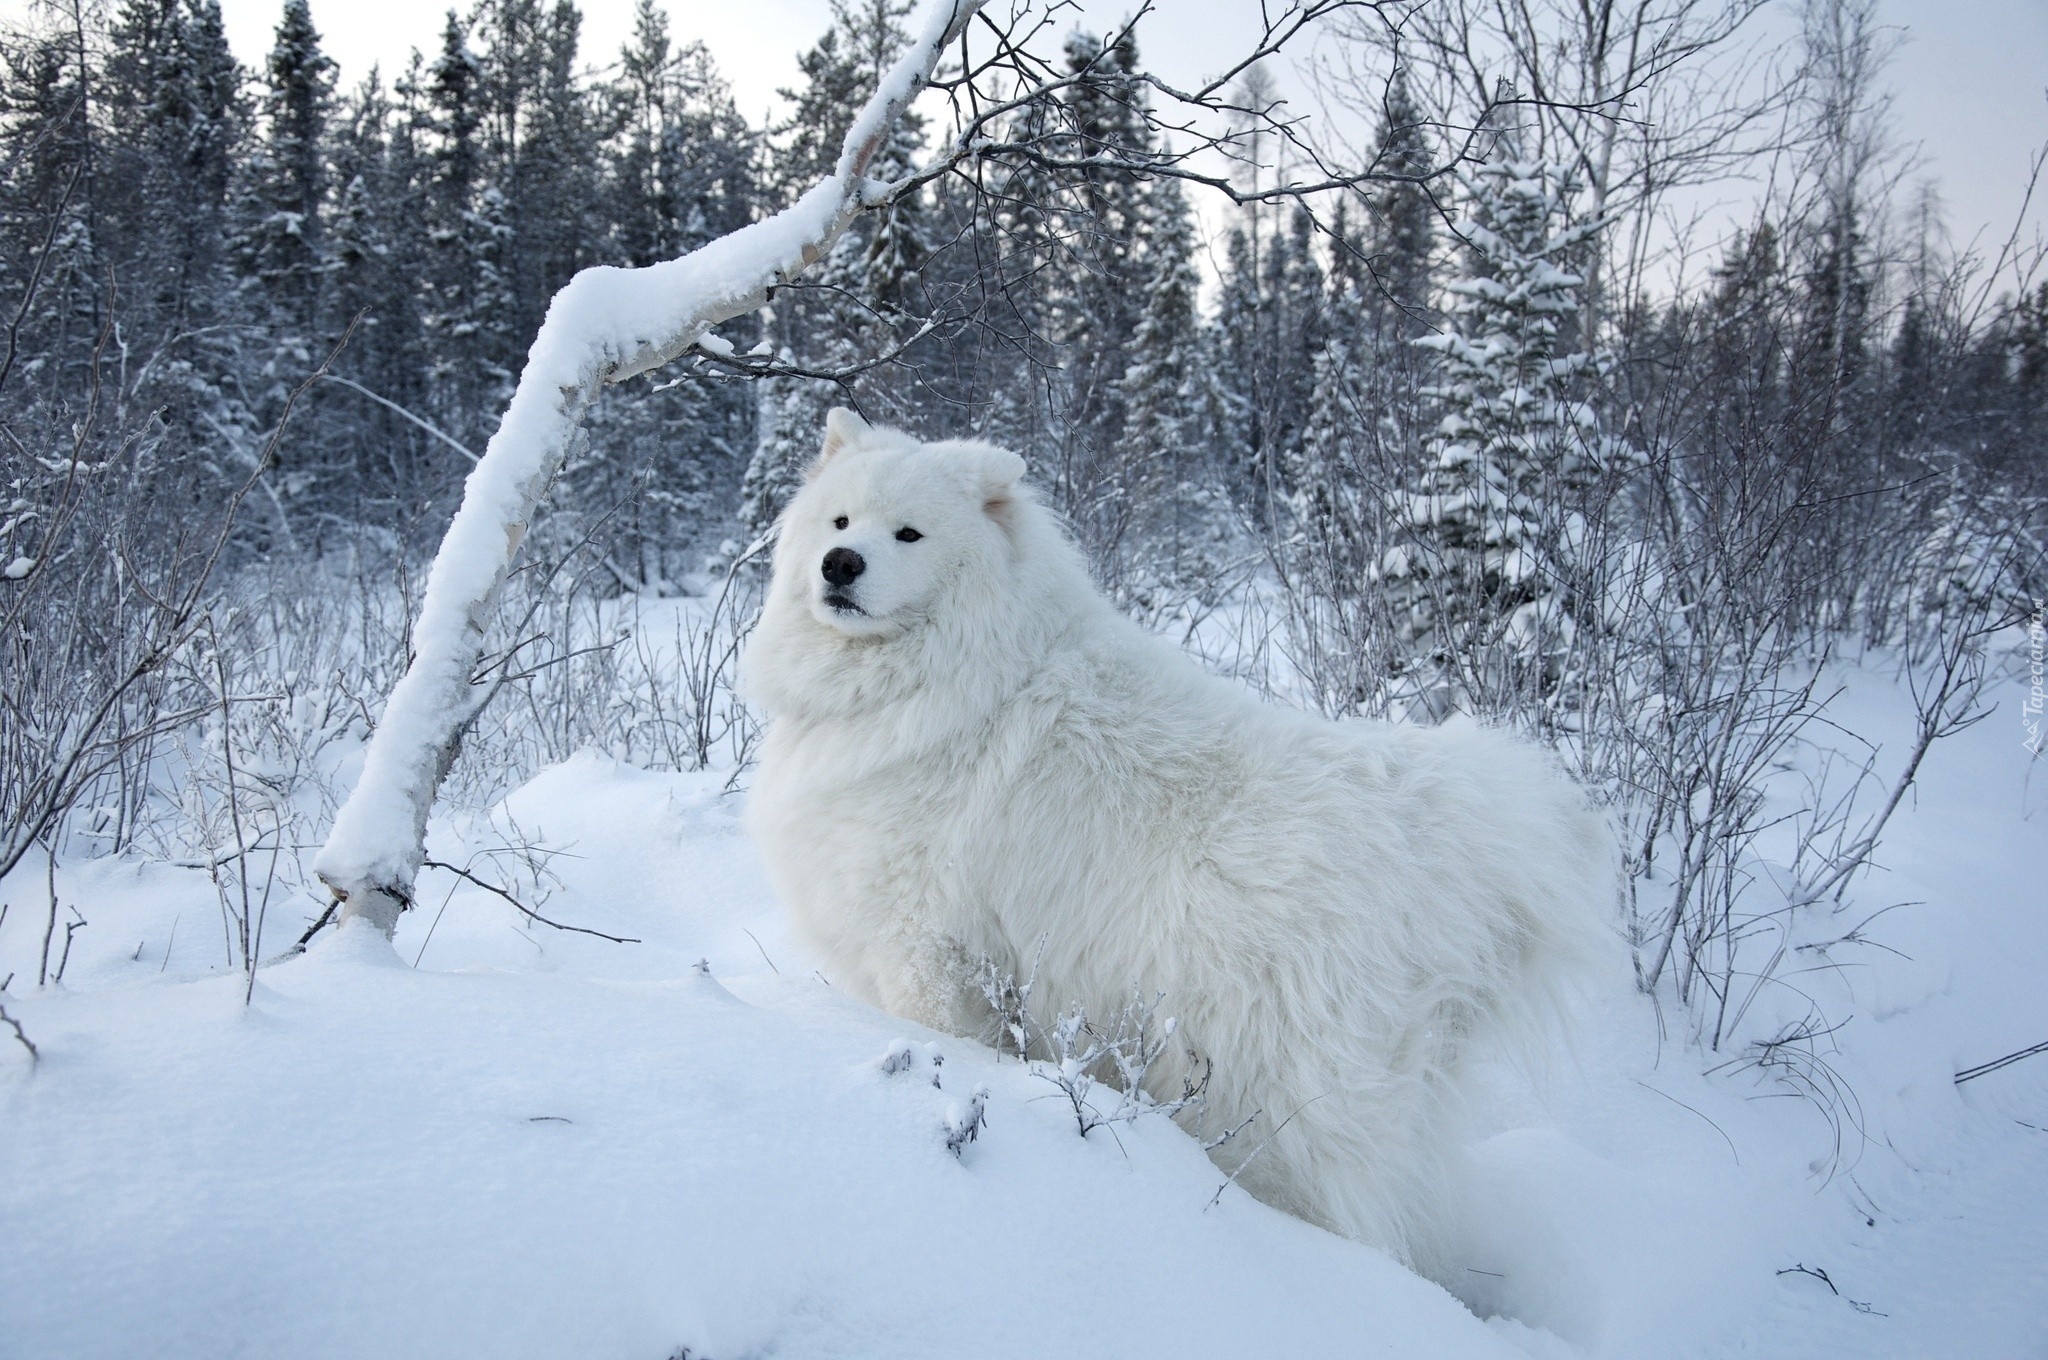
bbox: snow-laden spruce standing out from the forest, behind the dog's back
[1378,160,1628,711]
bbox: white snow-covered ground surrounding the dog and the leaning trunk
[0,651,2048,1360]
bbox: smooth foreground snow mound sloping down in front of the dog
[0,897,1513,1360]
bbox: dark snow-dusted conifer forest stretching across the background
[0,0,2048,590]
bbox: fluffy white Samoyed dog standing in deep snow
[743,410,1614,1272]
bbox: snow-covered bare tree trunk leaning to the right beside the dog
[313,0,985,934]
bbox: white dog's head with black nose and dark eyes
[774,408,1024,639]
